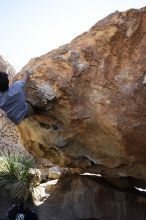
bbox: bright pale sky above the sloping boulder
[0,0,146,72]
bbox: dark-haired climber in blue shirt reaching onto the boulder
[0,69,33,124]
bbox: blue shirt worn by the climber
[0,80,28,124]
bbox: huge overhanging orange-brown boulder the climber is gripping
[19,8,146,179]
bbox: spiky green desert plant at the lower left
[0,153,36,201]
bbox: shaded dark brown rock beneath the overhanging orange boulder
[38,176,146,220]
